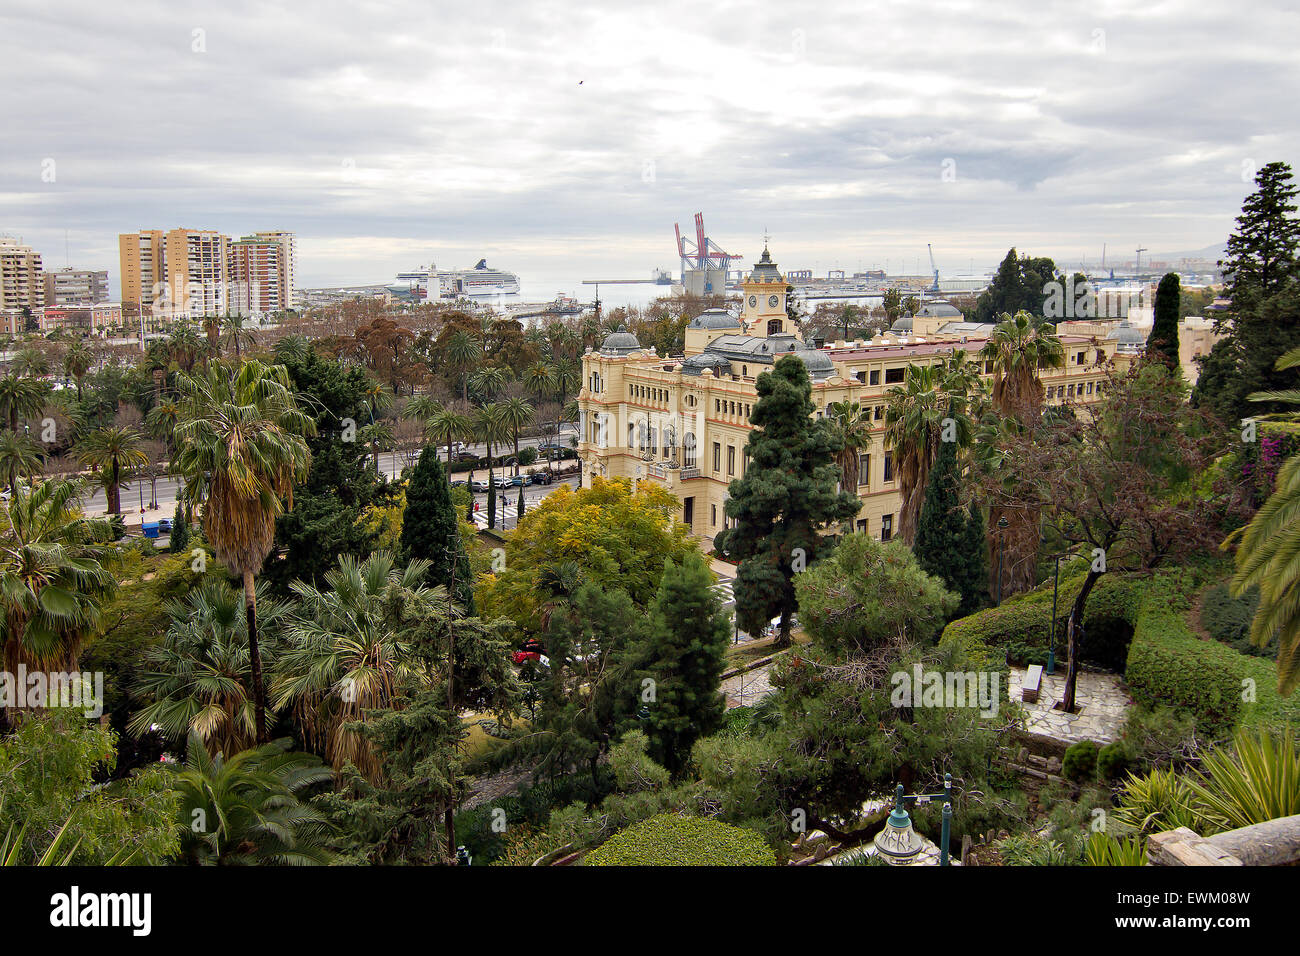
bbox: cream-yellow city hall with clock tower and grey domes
[577,248,1144,540]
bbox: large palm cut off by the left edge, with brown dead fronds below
[0,479,114,724]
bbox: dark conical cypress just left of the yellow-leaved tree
[400,446,475,615]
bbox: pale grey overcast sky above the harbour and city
[0,0,1300,290]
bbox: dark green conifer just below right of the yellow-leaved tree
[636,553,731,773]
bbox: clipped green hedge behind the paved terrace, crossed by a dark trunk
[939,571,1145,672]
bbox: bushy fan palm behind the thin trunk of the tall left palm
[130,578,287,754]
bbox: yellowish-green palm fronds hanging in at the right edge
[1229,349,1300,695]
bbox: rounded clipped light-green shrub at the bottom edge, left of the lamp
[582,813,776,866]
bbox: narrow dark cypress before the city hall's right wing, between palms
[913,431,988,615]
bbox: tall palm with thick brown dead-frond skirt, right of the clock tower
[979,310,1065,594]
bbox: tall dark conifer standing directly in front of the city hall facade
[714,355,858,646]
